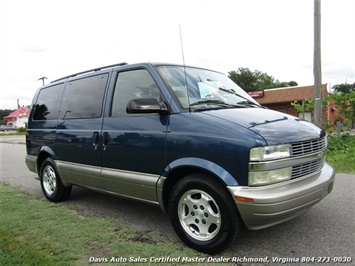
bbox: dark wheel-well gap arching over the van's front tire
[162,167,226,212]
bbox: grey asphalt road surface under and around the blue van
[0,136,355,265]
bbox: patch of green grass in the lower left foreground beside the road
[0,183,206,266]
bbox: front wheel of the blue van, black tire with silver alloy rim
[169,174,243,254]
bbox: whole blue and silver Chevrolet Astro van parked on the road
[26,63,335,254]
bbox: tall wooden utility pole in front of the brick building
[313,0,322,127]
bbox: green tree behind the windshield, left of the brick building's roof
[228,67,298,91]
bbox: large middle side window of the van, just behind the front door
[60,74,108,119]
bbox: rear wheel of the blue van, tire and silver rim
[40,158,72,202]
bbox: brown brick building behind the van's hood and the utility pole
[249,84,338,125]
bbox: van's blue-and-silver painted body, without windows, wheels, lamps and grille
[26,61,334,229]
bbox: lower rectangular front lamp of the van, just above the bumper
[248,167,292,186]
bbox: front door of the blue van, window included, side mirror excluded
[102,69,169,201]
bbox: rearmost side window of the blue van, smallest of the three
[33,84,63,120]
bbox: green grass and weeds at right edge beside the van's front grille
[327,134,355,174]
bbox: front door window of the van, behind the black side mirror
[111,69,161,116]
